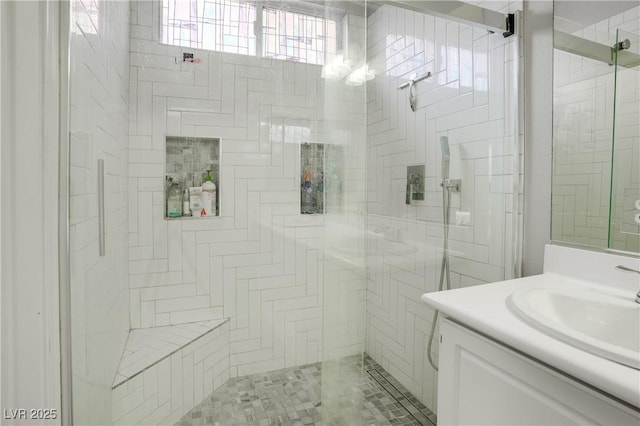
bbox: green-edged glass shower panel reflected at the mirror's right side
[609,30,640,253]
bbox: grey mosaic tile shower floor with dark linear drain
[176,355,436,426]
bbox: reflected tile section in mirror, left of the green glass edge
[551,40,615,247]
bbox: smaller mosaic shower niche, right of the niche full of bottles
[300,143,344,214]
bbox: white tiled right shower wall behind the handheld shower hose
[366,1,522,411]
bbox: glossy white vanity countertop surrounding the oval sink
[422,272,640,407]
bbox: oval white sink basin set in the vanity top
[507,287,640,370]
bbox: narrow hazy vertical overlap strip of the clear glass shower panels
[318,1,367,424]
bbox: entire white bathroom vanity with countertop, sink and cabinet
[422,246,640,426]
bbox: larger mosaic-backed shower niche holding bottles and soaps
[164,136,220,220]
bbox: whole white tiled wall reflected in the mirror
[551,6,640,252]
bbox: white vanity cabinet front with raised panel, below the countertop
[438,319,640,426]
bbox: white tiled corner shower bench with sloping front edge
[111,318,229,425]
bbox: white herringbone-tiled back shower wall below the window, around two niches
[128,1,366,377]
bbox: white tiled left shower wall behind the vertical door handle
[69,0,131,424]
